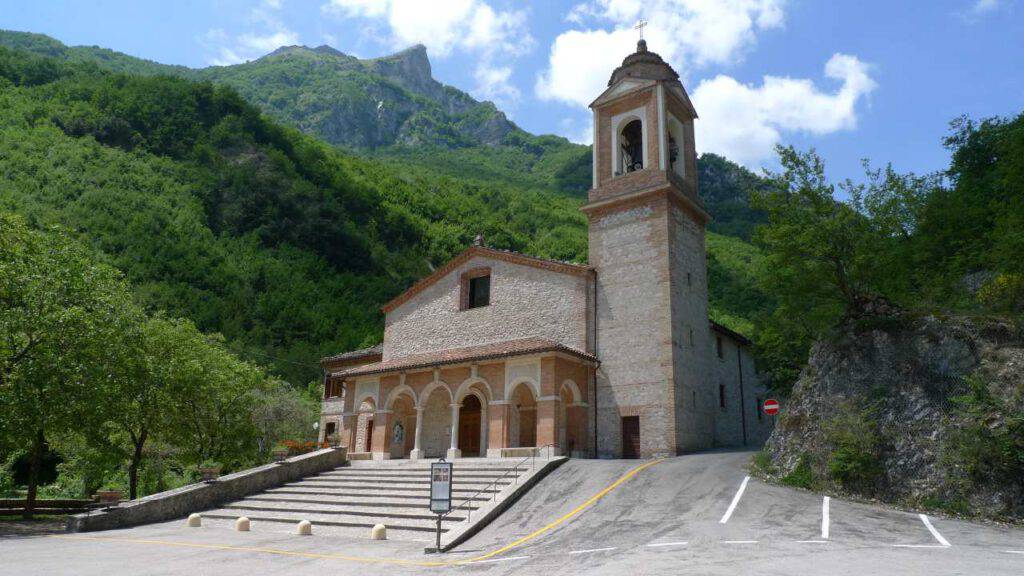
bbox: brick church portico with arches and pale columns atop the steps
[319,340,594,460]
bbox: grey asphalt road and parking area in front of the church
[0,452,1024,576]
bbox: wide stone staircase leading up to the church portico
[197,458,541,542]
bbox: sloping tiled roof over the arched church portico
[332,338,597,378]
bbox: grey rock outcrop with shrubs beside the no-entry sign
[766,317,1024,519]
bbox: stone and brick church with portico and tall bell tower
[319,40,770,459]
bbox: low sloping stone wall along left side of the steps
[68,448,345,532]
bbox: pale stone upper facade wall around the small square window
[384,256,589,361]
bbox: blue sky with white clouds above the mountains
[0,0,1024,179]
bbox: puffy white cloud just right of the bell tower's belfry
[692,53,877,167]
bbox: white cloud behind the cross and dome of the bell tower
[536,0,785,106]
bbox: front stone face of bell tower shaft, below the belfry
[590,197,675,457]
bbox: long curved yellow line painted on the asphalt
[50,458,664,568]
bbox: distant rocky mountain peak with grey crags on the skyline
[198,45,517,149]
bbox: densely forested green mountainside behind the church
[0,33,770,383]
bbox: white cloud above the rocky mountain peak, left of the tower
[322,0,534,106]
